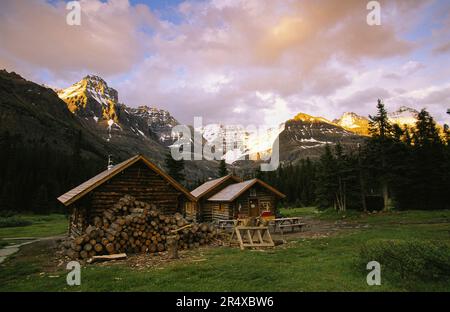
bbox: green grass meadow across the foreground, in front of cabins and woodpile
[0,211,450,291]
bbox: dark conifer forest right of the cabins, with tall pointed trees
[258,101,450,211]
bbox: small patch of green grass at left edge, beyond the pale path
[0,214,68,239]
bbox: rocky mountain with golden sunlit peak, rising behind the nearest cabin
[57,75,217,179]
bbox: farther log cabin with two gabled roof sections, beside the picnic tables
[191,175,286,221]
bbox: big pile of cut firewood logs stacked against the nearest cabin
[64,195,214,259]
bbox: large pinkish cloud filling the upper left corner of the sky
[0,0,157,76]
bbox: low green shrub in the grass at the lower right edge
[360,240,450,281]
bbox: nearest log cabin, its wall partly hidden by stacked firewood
[58,155,197,236]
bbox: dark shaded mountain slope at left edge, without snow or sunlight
[0,70,116,160]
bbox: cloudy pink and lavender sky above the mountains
[0,0,450,125]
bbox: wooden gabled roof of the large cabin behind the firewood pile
[58,155,197,206]
